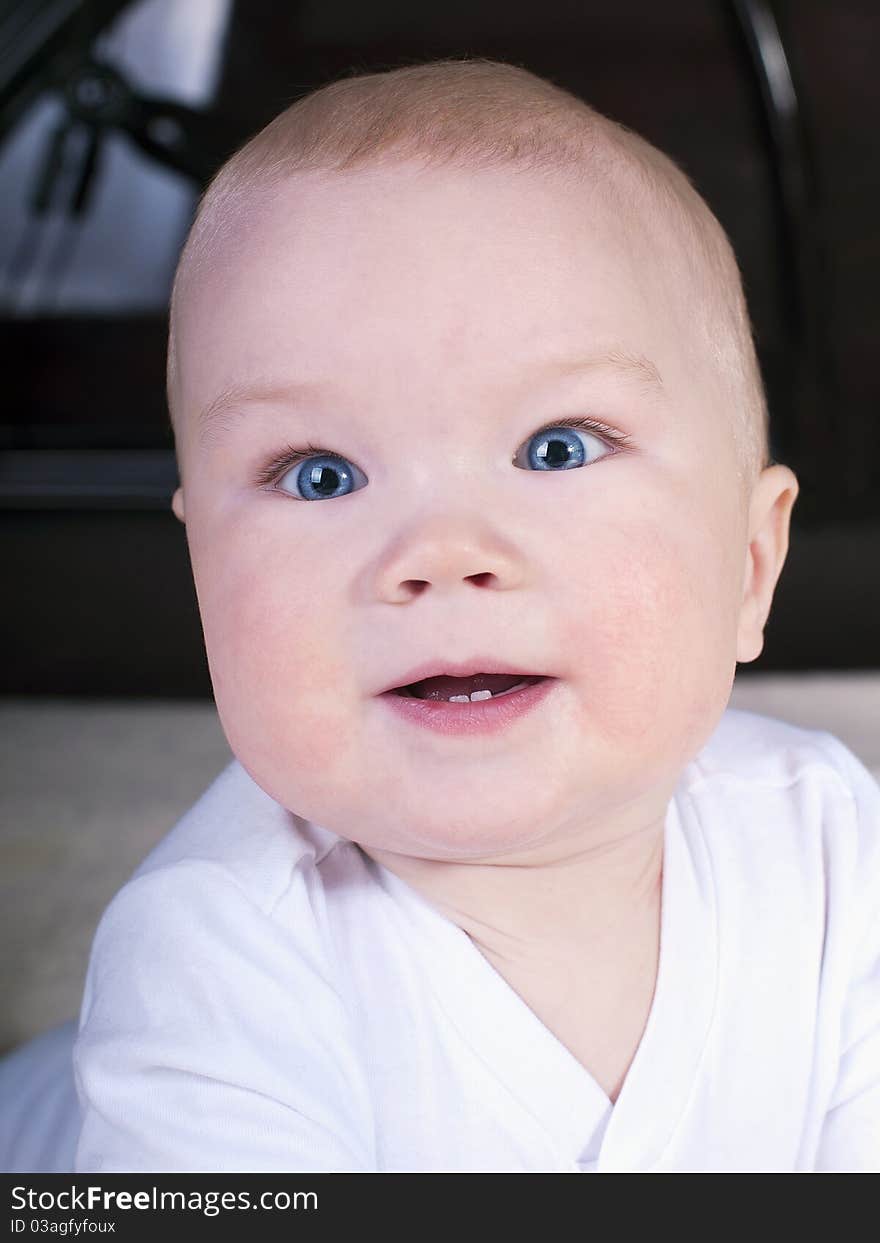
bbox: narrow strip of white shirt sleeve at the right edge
[815,740,880,1173]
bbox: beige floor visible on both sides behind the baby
[0,672,880,1053]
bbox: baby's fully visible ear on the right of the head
[736,465,799,663]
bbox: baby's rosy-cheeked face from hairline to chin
[175,165,752,859]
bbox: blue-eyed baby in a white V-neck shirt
[61,60,880,1172]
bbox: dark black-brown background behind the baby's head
[0,0,880,697]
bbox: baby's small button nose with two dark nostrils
[377,520,525,604]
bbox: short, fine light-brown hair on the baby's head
[168,57,769,485]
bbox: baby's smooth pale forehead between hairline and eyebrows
[178,165,684,422]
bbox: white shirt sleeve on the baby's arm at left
[73,860,374,1173]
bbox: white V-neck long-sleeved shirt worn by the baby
[75,709,880,1172]
